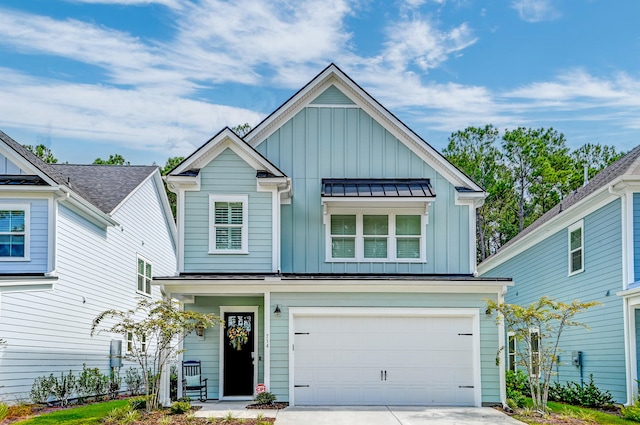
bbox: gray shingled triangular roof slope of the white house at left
[51,164,158,214]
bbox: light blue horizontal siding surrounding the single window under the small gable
[184,148,273,273]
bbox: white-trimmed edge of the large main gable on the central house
[244,63,484,196]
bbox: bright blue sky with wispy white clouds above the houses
[0,0,640,165]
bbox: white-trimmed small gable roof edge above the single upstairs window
[168,127,286,177]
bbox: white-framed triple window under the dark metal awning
[327,212,425,262]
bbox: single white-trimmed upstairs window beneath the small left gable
[209,195,249,254]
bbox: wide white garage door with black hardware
[293,316,475,406]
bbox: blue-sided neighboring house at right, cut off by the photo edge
[478,147,640,403]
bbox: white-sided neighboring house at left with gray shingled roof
[0,132,176,401]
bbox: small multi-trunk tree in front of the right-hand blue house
[488,296,600,412]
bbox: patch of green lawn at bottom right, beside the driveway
[514,401,638,425]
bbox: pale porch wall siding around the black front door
[182,296,265,399]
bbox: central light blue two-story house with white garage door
[161,65,511,406]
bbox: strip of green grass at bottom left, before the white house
[13,400,129,425]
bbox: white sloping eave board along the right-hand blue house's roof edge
[478,186,618,276]
